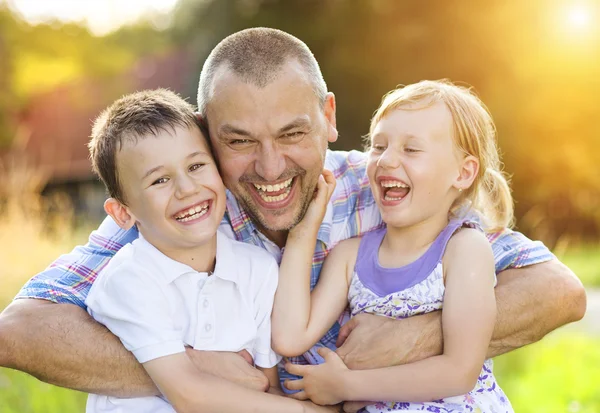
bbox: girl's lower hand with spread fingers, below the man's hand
[284,347,350,405]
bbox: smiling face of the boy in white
[116,126,225,254]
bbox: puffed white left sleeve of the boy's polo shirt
[86,260,185,363]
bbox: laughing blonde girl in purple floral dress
[272,81,512,413]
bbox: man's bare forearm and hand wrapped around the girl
[337,259,586,369]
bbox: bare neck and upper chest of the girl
[379,214,448,267]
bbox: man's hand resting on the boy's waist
[186,348,269,392]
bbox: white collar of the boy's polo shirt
[137,231,239,284]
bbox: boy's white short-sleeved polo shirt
[85,231,280,412]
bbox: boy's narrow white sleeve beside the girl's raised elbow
[254,257,281,368]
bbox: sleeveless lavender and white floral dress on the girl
[348,220,513,413]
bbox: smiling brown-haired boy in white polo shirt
[86,90,322,413]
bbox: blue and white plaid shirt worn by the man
[16,151,554,379]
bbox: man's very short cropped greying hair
[198,27,327,118]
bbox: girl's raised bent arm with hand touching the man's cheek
[271,171,353,357]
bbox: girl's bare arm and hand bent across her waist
[288,229,496,404]
